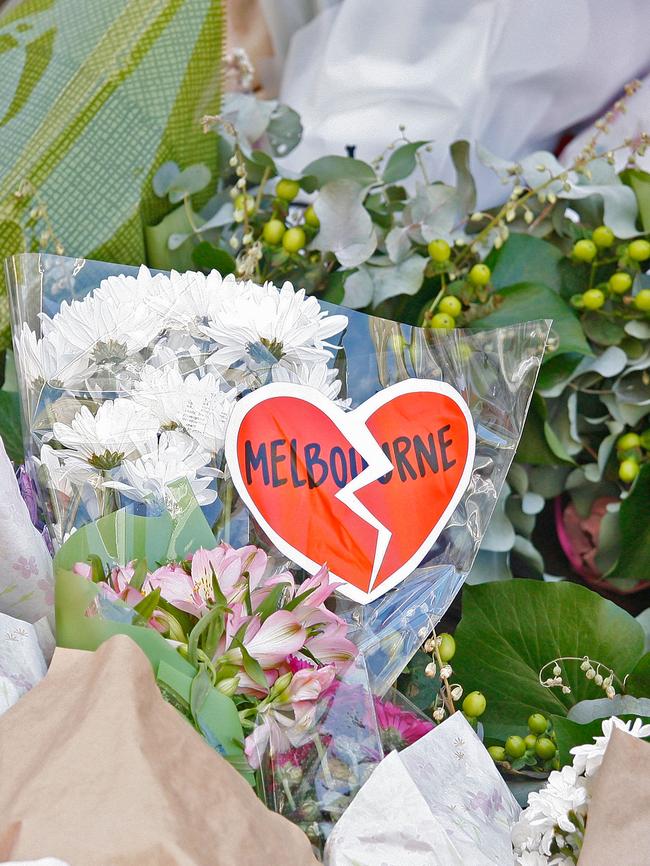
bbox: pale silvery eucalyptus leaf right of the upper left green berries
[312,177,378,264]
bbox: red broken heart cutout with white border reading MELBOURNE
[226,379,475,603]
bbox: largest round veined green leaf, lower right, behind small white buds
[453,579,644,742]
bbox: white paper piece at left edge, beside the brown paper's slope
[0,613,54,716]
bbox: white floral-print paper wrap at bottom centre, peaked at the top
[325,713,521,866]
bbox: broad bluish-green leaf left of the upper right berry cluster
[488,233,562,292]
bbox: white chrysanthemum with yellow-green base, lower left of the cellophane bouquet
[52,398,160,470]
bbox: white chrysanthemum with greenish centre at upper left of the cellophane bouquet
[42,284,160,365]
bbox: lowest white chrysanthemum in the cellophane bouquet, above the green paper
[104,431,217,505]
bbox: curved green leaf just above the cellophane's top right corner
[472,283,592,357]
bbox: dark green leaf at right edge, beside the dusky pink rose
[607,463,650,581]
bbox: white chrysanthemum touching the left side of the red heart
[133,366,237,453]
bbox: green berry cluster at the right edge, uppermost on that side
[571,226,650,313]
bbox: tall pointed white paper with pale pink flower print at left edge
[0,438,54,627]
